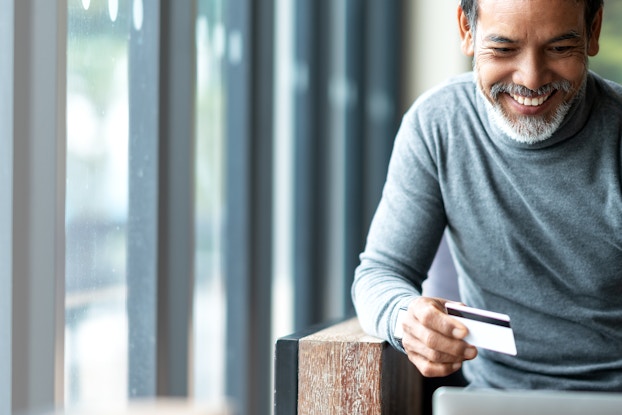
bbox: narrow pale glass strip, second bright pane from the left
[194,0,226,402]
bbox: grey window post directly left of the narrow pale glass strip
[156,0,197,396]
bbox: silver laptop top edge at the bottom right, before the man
[432,387,622,415]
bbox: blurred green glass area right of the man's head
[590,1,622,83]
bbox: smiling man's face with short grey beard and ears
[459,0,602,143]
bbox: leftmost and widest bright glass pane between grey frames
[65,0,130,406]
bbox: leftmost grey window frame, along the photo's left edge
[0,0,67,413]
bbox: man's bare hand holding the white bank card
[402,297,477,377]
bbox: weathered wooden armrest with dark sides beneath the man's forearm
[274,317,463,415]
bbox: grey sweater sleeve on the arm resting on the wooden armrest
[352,105,447,351]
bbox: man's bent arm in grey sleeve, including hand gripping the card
[352,103,476,376]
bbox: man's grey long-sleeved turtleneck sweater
[352,73,622,391]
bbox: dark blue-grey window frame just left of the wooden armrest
[224,0,274,415]
